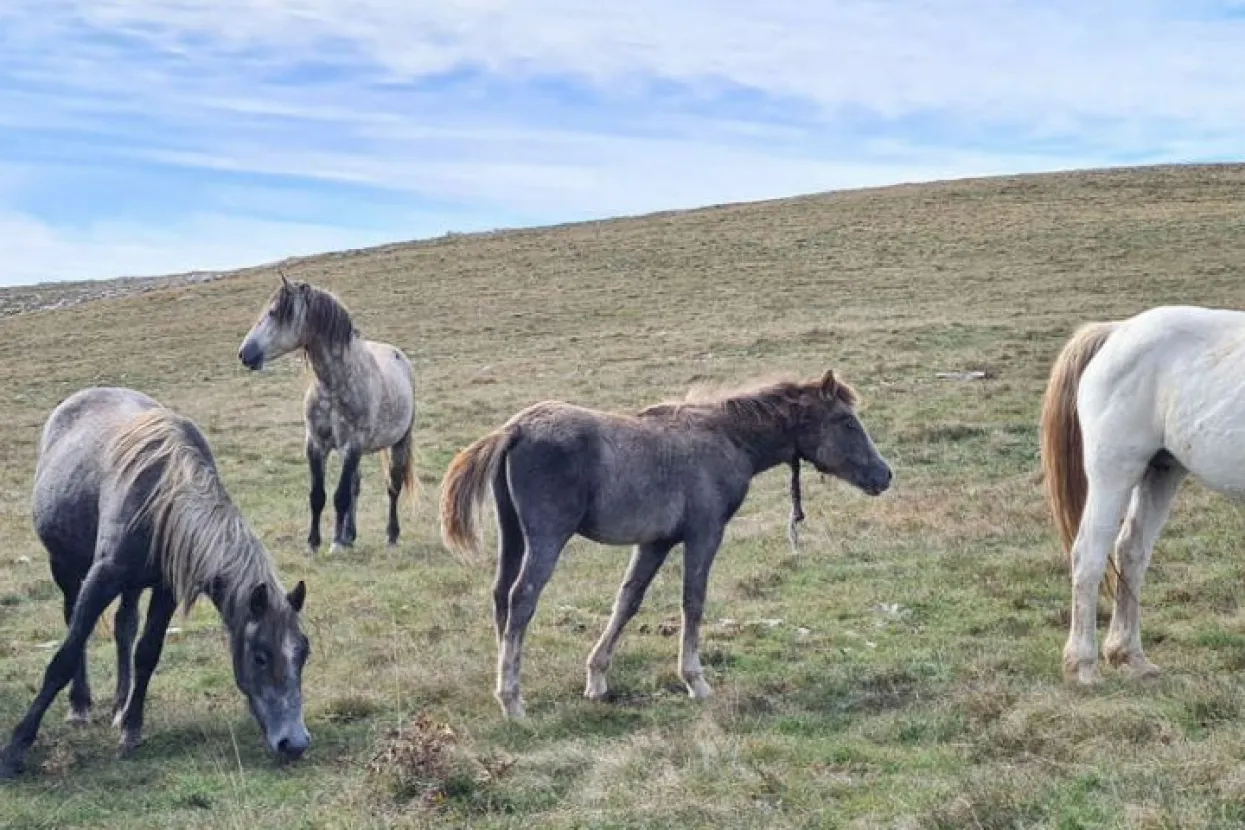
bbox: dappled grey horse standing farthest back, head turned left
[238,274,416,553]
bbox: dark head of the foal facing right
[796,371,891,495]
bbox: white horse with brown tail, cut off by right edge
[1041,306,1245,683]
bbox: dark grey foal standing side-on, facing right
[441,372,890,717]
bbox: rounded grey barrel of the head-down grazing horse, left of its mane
[32,387,159,569]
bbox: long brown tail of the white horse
[1041,322,1117,559]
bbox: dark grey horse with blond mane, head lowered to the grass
[0,388,311,779]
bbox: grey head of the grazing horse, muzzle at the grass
[230,582,311,760]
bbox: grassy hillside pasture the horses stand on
[0,167,1245,830]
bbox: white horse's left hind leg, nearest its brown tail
[1063,452,1145,684]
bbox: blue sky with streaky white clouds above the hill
[0,0,1245,285]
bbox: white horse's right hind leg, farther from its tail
[1103,463,1185,677]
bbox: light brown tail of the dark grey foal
[441,427,518,560]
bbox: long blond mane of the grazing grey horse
[108,407,280,612]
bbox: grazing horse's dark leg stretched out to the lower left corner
[0,560,121,779]
